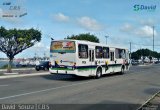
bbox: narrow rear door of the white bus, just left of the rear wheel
[89,49,95,74]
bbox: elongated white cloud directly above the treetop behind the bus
[77,16,102,31]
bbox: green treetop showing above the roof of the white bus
[67,33,99,43]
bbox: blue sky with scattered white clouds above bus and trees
[0,0,160,58]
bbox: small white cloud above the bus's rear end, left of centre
[53,13,69,22]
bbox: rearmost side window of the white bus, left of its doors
[78,44,88,58]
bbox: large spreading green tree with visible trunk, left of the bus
[0,27,41,72]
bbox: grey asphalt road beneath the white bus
[0,64,160,109]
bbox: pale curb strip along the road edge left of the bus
[0,72,50,79]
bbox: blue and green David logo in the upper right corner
[133,4,156,12]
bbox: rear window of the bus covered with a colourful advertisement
[50,41,76,53]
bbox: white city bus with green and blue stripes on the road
[49,40,129,78]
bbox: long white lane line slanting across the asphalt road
[0,80,95,100]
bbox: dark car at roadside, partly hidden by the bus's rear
[35,61,49,71]
